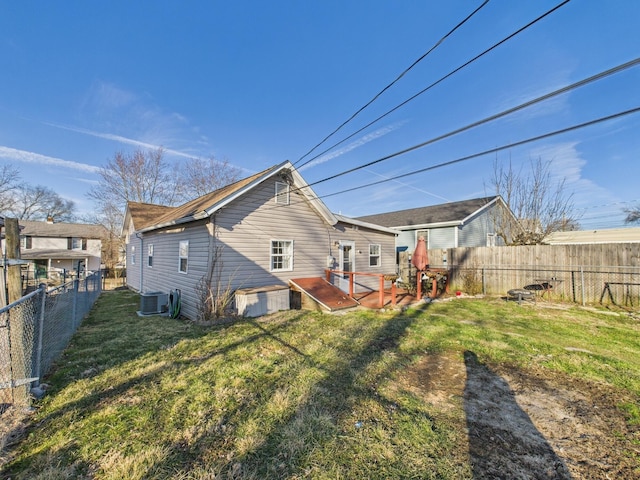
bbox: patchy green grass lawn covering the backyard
[2,291,640,479]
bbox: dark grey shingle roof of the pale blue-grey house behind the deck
[357,196,500,228]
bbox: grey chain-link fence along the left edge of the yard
[0,273,102,412]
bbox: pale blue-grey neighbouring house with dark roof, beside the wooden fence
[358,196,513,255]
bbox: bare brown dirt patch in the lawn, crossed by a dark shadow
[401,352,640,480]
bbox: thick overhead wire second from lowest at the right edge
[309,57,640,186]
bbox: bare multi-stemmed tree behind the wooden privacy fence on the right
[492,158,579,245]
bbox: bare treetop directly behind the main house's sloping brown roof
[180,157,242,201]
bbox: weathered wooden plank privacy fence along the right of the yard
[420,243,640,307]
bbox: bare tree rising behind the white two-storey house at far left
[8,184,75,222]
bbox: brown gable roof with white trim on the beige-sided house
[125,161,337,232]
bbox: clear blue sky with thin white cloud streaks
[0,0,640,228]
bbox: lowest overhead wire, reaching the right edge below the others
[318,107,640,198]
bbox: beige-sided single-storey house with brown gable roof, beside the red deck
[123,162,396,319]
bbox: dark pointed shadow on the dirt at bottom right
[464,351,571,480]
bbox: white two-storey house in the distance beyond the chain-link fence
[19,220,107,276]
